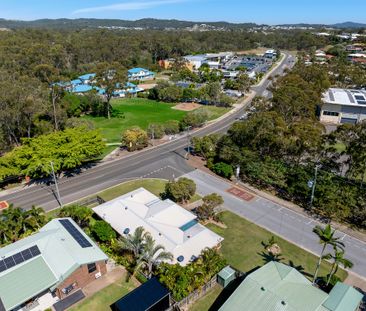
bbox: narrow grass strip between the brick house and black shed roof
[69,278,136,311]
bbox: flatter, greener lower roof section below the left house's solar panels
[0,256,57,310]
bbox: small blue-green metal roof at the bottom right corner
[323,282,363,311]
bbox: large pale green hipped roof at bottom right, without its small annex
[220,262,328,311]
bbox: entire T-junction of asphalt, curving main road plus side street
[0,54,366,277]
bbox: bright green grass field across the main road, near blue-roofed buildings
[83,98,186,143]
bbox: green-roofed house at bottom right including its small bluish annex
[219,261,363,311]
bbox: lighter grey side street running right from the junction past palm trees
[185,170,366,277]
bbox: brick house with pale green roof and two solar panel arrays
[0,218,108,311]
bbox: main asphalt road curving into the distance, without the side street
[0,54,293,210]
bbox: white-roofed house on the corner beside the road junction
[93,188,223,265]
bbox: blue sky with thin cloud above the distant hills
[0,0,366,24]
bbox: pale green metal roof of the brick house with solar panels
[0,218,108,306]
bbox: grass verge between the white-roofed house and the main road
[98,179,167,201]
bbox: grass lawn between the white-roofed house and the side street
[208,212,347,280]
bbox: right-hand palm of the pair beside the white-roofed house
[142,233,173,279]
